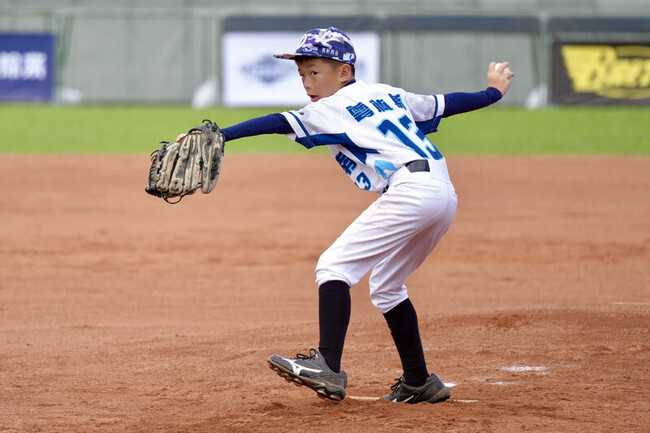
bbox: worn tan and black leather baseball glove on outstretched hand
[145,119,224,204]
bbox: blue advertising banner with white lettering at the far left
[0,33,54,101]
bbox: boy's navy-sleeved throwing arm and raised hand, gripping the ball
[442,62,515,117]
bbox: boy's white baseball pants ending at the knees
[316,167,458,313]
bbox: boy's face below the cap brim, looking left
[297,58,350,102]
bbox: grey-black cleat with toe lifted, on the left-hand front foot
[266,349,348,402]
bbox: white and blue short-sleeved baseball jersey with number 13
[282,81,448,192]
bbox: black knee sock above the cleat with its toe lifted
[318,281,352,373]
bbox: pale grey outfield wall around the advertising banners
[0,0,650,105]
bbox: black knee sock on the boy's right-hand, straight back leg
[384,299,429,386]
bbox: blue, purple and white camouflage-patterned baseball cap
[273,27,357,65]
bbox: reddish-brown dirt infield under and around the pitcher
[0,155,650,433]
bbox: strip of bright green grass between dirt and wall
[0,104,650,155]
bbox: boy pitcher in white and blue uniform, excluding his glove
[194,27,514,403]
